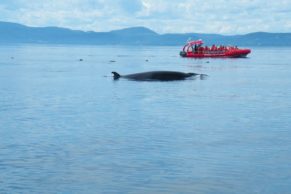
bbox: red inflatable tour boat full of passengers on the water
[180,40,251,58]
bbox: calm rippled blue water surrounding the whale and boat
[0,45,291,194]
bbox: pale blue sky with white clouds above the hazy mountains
[0,0,291,34]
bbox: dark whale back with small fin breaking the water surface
[112,71,206,81]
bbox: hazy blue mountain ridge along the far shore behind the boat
[0,21,291,46]
